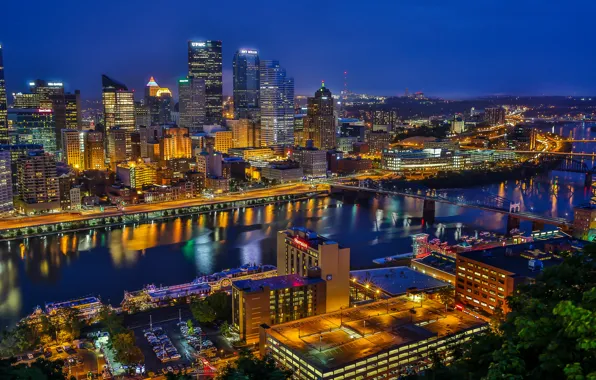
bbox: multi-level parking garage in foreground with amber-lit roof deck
[260,296,488,380]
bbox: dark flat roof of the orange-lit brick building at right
[458,238,563,277]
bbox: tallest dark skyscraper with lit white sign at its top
[188,40,223,125]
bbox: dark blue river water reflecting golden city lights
[0,124,596,327]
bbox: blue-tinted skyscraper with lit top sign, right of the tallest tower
[233,49,261,121]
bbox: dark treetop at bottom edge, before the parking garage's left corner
[217,351,292,380]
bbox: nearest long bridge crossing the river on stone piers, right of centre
[331,181,572,232]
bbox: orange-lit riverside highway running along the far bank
[0,183,330,231]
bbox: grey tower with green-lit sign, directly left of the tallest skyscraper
[178,77,205,133]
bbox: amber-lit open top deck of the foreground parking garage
[267,296,486,377]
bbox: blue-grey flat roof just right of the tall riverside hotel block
[350,267,449,297]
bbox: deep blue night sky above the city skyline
[0,0,596,99]
